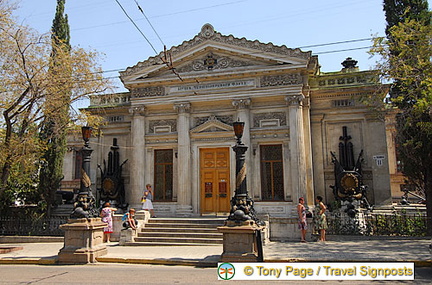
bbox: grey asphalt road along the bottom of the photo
[0,263,432,285]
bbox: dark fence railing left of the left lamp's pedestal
[0,216,69,236]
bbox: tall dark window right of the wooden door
[260,145,284,201]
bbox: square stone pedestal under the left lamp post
[58,218,107,264]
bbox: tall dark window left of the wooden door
[154,149,173,201]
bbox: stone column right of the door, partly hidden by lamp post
[232,98,251,195]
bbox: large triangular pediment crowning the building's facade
[120,24,311,84]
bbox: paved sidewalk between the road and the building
[0,238,432,267]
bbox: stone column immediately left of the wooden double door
[174,102,192,217]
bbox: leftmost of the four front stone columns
[126,105,146,209]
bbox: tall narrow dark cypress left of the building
[39,0,71,215]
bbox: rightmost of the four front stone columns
[285,94,309,205]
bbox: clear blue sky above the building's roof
[16,0,432,96]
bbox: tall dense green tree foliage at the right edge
[371,0,432,235]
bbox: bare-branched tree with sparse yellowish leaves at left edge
[0,0,109,210]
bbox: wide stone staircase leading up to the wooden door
[125,218,226,246]
